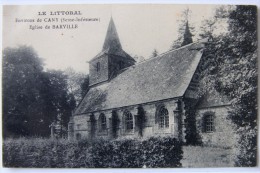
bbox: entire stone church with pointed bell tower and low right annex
[68,18,234,147]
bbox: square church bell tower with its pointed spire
[89,17,135,86]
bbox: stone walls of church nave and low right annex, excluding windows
[69,100,235,147]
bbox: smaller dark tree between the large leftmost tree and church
[42,70,76,137]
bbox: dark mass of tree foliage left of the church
[3,46,75,137]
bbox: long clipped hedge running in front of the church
[3,137,183,168]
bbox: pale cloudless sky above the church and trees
[3,4,220,74]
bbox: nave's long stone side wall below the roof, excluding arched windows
[71,100,182,139]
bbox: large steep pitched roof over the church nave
[74,43,204,114]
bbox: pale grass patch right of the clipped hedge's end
[181,146,234,168]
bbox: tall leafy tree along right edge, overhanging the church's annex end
[198,6,257,166]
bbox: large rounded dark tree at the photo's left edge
[3,46,43,137]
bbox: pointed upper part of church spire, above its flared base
[102,17,122,51]
